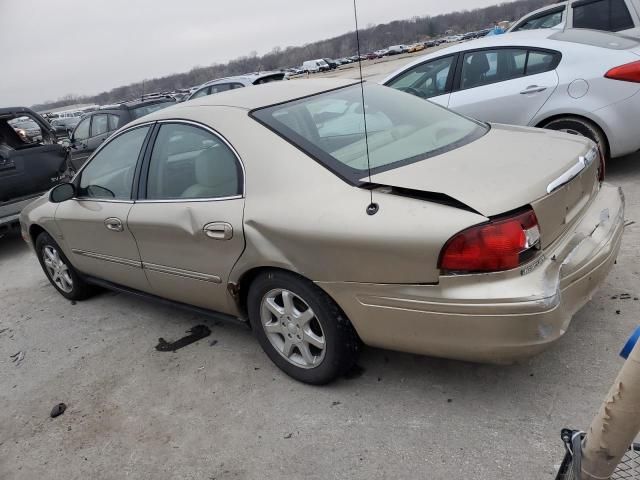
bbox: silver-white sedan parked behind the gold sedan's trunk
[382,29,640,157]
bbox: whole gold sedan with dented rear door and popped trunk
[21,80,624,384]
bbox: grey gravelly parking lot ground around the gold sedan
[0,58,640,479]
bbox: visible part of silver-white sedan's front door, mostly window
[385,54,458,107]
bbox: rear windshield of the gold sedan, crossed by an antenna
[252,84,488,184]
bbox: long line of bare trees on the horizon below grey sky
[32,0,555,111]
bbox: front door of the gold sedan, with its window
[55,126,151,291]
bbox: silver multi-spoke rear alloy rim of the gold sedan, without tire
[260,288,326,368]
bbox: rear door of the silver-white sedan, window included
[449,47,561,125]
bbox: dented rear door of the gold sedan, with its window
[127,122,244,313]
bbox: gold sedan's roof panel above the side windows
[131,78,359,125]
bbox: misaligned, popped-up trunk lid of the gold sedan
[371,125,599,247]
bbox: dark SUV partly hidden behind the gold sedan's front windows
[70,97,176,171]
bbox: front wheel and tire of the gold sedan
[35,232,93,300]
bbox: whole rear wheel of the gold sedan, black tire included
[247,270,360,385]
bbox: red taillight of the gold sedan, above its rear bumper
[439,209,540,273]
